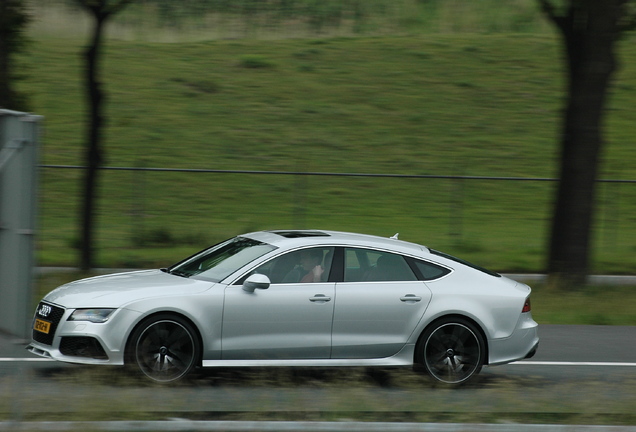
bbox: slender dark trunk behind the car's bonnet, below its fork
[80,13,105,270]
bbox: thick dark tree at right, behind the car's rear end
[538,0,636,289]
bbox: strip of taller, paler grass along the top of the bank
[30,0,550,42]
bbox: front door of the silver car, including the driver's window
[222,247,335,360]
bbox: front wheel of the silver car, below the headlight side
[126,314,201,383]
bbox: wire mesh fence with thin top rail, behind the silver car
[40,165,636,272]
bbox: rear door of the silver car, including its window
[331,248,431,358]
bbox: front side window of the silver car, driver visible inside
[251,247,334,284]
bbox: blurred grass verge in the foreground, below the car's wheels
[0,356,636,424]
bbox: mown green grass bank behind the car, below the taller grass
[16,27,636,274]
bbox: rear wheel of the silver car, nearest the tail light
[416,317,486,385]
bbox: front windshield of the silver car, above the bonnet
[168,237,276,282]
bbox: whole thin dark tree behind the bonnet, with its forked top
[74,0,134,270]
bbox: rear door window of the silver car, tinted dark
[344,248,418,282]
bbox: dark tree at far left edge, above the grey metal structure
[0,0,29,110]
